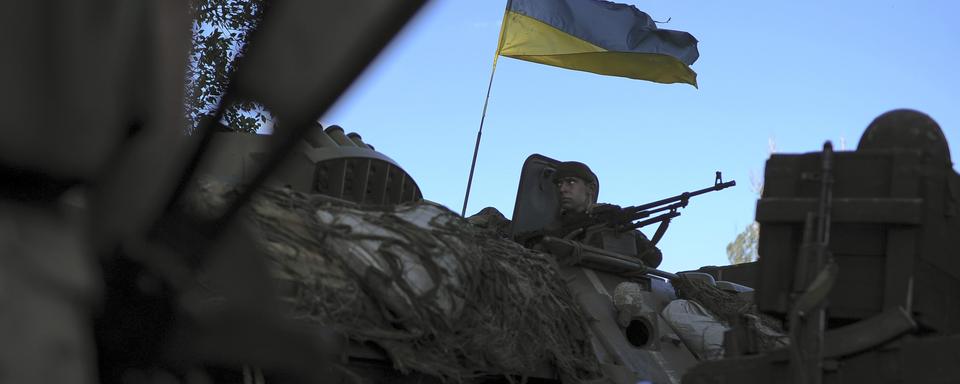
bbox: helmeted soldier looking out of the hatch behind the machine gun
[553,161,663,268]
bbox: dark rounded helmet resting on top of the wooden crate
[857,109,951,164]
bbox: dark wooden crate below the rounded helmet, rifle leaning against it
[755,150,960,333]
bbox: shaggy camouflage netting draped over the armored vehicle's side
[189,181,600,381]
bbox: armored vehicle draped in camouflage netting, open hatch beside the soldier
[199,126,720,383]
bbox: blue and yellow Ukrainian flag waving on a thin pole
[497,0,700,87]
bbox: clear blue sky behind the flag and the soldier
[321,0,960,271]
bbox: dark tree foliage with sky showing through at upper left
[184,0,269,133]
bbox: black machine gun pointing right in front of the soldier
[547,171,737,245]
